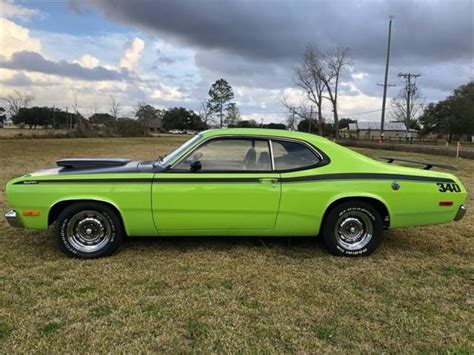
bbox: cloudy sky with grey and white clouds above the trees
[0,0,474,122]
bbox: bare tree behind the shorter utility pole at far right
[390,79,423,130]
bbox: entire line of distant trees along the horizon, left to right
[0,62,474,142]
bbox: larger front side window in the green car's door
[172,138,271,172]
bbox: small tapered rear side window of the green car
[272,140,321,170]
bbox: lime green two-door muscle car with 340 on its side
[5,129,467,258]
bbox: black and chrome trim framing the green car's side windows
[164,134,331,174]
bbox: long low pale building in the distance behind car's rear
[341,122,418,139]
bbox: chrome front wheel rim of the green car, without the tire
[66,211,112,253]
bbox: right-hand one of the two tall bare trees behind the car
[319,47,350,139]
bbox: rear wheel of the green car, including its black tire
[323,200,383,256]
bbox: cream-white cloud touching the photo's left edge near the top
[0,17,41,58]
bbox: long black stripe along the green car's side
[15,173,455,185]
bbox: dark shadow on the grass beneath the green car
[10,229,458,258]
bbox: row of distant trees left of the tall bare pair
[0,79,286,136]
